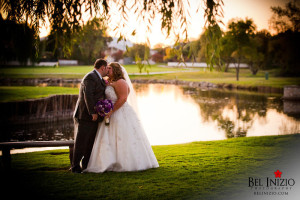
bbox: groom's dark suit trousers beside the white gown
[72,120,98,169]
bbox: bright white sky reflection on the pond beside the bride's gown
[137,85,226,144]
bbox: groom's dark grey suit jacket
[73,70,106,122]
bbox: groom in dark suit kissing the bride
[71,59,107,173]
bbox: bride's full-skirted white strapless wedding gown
[84,86,159,173]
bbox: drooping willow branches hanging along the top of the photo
[0,0,223,65]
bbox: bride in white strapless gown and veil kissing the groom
[84,63,159,173]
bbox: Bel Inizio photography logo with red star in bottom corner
[248,170,296,196]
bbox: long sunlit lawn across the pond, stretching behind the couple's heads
[0,65,300,88]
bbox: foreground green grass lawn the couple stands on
[1,134,300,200]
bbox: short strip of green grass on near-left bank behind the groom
[0,86,79,102]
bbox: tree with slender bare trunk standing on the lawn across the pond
[228,18,255,81]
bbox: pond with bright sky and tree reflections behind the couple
[0,84,300,148]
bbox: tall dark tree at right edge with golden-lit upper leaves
[268,2,300,76]
